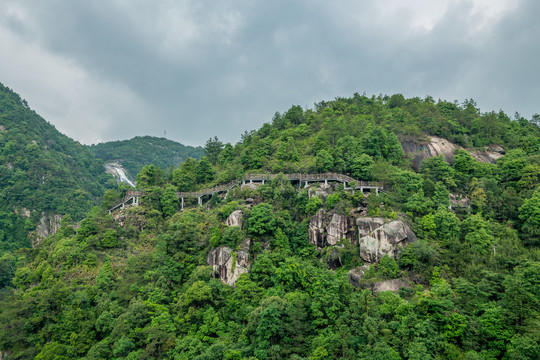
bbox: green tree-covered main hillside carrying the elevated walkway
[0,94,540,360]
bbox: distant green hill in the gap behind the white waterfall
[90,136,204,179]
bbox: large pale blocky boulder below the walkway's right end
[356,218,416,263]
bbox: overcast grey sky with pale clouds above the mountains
[0,0,540,145]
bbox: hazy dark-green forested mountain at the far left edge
[0,84,114,256]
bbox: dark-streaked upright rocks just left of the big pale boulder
[308,209,356,248]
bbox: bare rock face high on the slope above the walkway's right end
[401,136,504,170]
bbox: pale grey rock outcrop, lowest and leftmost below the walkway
[207,239,251,286]
